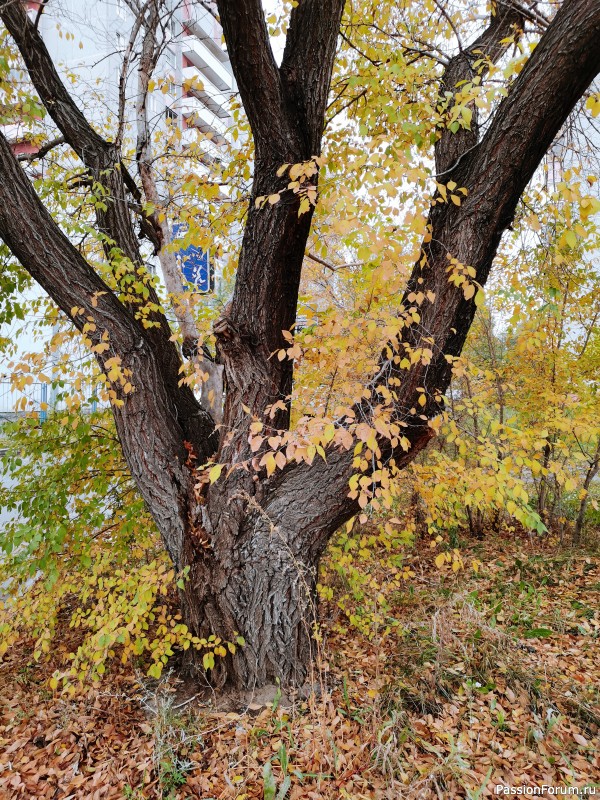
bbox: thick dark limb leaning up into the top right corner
[390,0,600,468]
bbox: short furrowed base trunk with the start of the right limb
[173,444,358,689]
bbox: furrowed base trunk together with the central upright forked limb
[166,0,344,689]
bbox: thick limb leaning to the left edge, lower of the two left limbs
[0,125,214,564]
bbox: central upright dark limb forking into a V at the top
[215,0,344,461]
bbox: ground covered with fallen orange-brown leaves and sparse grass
[0,535,600,800]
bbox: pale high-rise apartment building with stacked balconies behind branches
[5,0,236,152]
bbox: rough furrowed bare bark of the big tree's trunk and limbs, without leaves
[0,0,600,688]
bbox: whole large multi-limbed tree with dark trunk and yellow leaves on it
[0,0,600,689]
